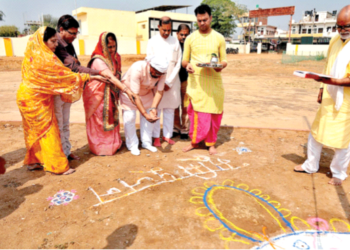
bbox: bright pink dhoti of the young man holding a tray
[187,102,223,147]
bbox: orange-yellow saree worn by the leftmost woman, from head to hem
[17,27,90,174]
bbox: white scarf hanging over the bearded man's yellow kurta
[327,42,350,111]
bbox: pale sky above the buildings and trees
[0,0,350,36]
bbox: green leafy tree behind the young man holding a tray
[202,0,247,37]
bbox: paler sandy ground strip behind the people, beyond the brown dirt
[0,54,324,129]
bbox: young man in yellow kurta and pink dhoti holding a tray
[182,4,227,154]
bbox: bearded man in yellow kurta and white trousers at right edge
[294,5,350,185]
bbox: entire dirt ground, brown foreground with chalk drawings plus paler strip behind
[0,55,350,249]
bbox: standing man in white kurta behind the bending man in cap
[147,17,182,147]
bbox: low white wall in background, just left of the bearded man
[286,43,329,57]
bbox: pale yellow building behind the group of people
[72,5,196,41]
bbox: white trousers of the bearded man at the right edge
[301,134,350,180]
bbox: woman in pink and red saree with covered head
[83,32,133,155]
